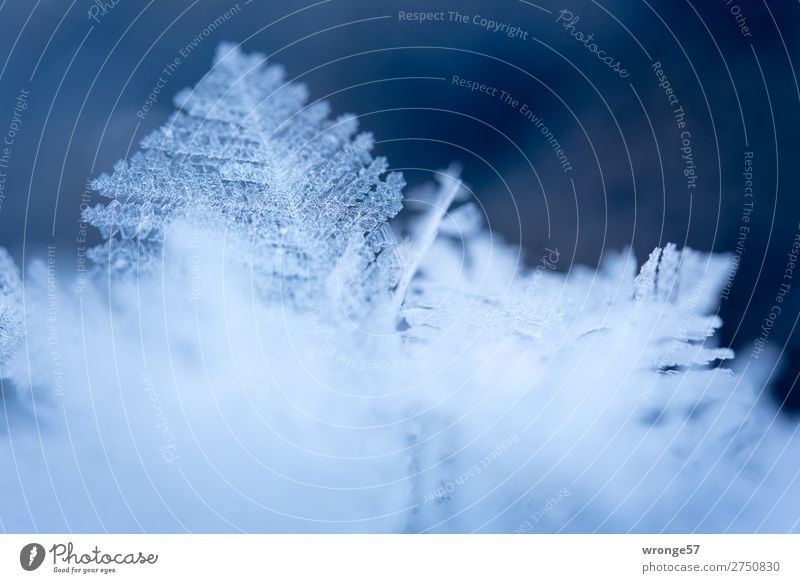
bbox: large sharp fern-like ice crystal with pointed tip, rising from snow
[84,44,404,315]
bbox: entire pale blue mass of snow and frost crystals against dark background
[0,45,800,532]
